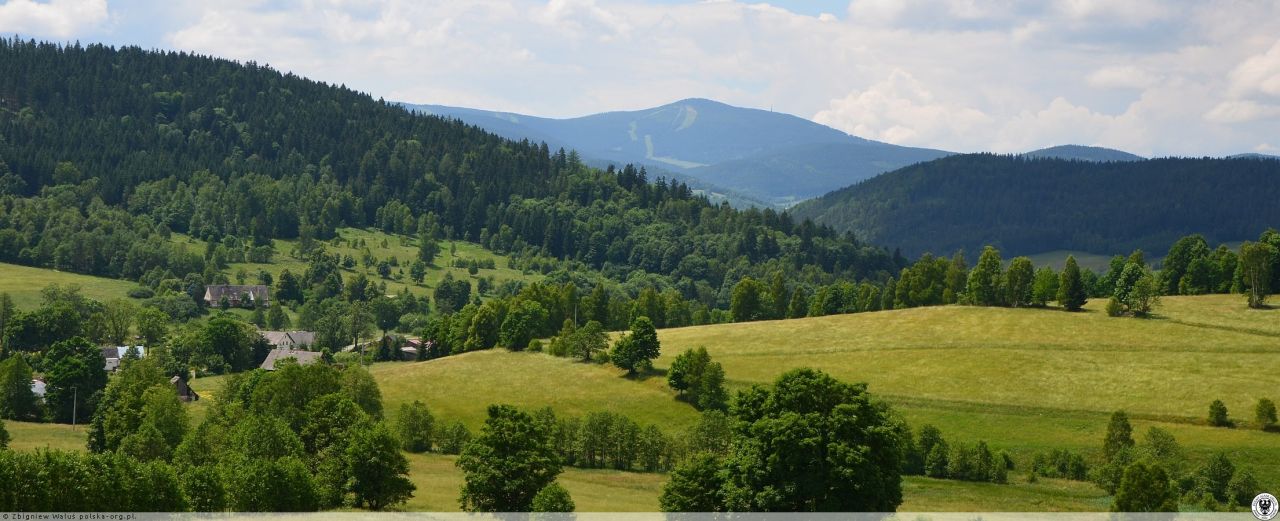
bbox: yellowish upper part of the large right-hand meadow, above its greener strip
[655,296,1280,421]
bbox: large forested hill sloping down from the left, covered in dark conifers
[0,40,901,297]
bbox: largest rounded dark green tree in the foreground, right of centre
[722,369,902,512]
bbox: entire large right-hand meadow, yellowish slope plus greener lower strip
[655,296,1280,488]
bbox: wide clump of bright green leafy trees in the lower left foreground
[64,357,413,512]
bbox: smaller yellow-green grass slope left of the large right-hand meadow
[371,349,696,431]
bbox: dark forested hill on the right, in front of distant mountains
[794,154,1280,255]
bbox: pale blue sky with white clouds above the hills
[0,0,1280,156]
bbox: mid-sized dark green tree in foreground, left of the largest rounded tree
[457,405,561,512]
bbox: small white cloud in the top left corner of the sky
[0,0,108,38]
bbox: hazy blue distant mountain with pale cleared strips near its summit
[404,99,950,206]
